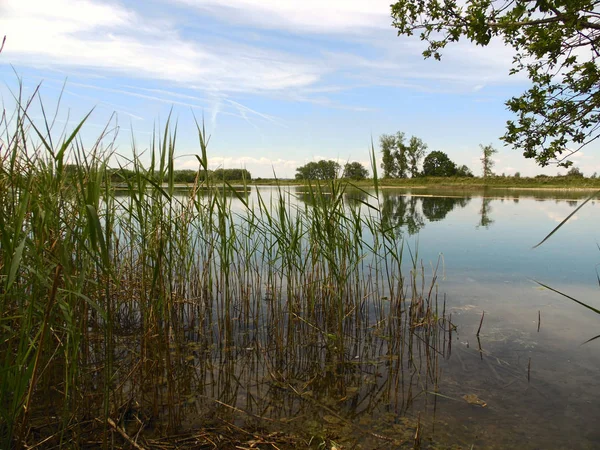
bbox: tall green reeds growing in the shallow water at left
[0,89,452,448]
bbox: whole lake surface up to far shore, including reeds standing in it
[10,180,600,449]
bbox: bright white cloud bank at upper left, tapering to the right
[0,0,324,92]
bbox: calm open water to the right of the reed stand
[244,188,600,449]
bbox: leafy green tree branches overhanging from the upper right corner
[392,0,600,167]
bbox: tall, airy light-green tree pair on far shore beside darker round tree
[379,131,427,178]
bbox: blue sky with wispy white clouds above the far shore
[0,0,600,178]
